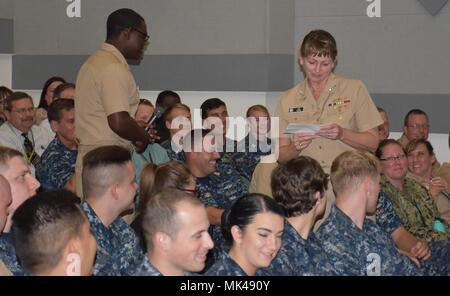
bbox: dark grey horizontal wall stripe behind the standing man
[12,54,294,92]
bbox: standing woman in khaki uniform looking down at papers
[275,30,383,224]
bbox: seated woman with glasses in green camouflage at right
[375,139,450,242]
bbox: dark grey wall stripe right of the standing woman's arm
[372,94,450,134]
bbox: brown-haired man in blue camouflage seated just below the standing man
[81,146,144,276]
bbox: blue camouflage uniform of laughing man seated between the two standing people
[196,161,248,259]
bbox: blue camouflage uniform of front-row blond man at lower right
[316,205,422,276]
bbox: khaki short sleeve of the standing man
[100,64,135,116]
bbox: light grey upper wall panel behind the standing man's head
[14,0,294,55]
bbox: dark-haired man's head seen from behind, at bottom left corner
[13,190,96,276]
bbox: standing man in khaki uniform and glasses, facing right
[75,8,150,196]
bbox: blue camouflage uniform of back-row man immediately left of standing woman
[231,134,272,181]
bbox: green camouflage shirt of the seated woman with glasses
[381,176,450,242]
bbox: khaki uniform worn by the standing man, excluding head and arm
[75,43,139,197]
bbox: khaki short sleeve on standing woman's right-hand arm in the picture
[355,81,383,132]
